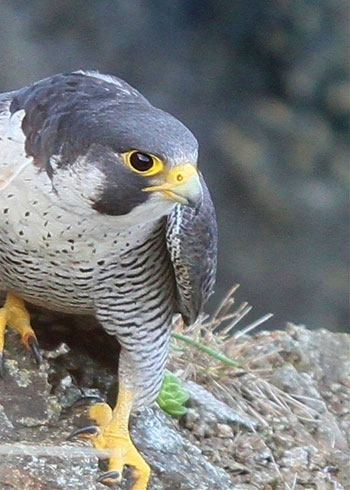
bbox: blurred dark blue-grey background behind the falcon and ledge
[0,0,349,330]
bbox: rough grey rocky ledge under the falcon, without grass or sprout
[0,316,350,490]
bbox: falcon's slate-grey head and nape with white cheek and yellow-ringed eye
[10,72,202,221]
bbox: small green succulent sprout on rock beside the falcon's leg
[157,371,190,417]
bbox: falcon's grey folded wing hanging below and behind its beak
[166,176,217,325]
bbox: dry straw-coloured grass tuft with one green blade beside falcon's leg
[170,285,317,427]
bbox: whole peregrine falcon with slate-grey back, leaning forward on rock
[0,71,217,490]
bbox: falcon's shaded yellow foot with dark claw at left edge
[0,294,41,376]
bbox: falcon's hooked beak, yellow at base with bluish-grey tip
[143,163,202,208]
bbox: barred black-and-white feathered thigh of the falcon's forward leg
[95,221,175,406]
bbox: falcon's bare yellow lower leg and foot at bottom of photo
[72,385,150,490]
